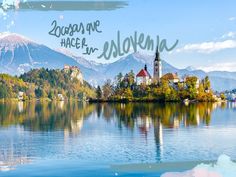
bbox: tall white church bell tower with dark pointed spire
[153,47,162,83]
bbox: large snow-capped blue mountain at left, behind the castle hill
[0,33,103,82]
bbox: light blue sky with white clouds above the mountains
[0,0,236,71]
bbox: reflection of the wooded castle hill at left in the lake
[0,102,95,134]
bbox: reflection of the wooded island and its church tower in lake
[93,103,226,162]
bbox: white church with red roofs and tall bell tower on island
[136,49,180,85]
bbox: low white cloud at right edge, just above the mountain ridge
[197,62,236,72]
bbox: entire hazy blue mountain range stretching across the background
[0,33,236,91]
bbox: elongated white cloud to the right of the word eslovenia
[176,40,236,53]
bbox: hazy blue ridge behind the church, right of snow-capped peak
[100,53,236,91]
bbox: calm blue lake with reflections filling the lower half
[0,102,236,177]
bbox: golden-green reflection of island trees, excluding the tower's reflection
[109,103,226,129]
